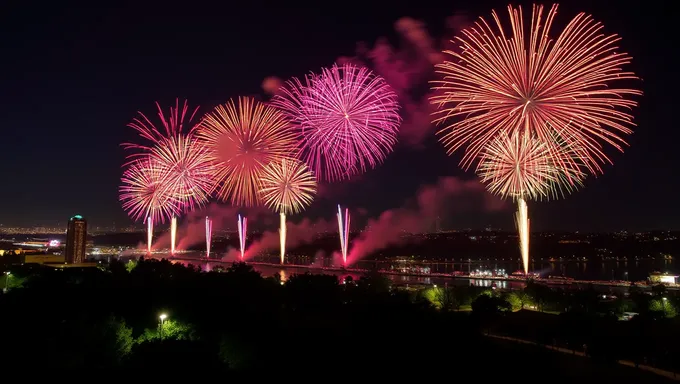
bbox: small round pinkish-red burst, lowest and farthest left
[119,157,179,223]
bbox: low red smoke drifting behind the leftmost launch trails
[150,204,269,250]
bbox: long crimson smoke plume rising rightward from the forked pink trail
[347,177,506,264]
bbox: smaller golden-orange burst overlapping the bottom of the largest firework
[477,132,585,200]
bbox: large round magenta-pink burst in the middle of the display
[273,64,401,181]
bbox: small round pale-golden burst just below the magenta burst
[260,159,316,214]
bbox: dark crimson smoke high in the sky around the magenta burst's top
[262,14,470,147]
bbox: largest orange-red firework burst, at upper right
[433,5,641,172]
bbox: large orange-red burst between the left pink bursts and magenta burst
[196,97,296,206]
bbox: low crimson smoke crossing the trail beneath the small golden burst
[238,219,338,261]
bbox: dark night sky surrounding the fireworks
[0,1,680,230]
